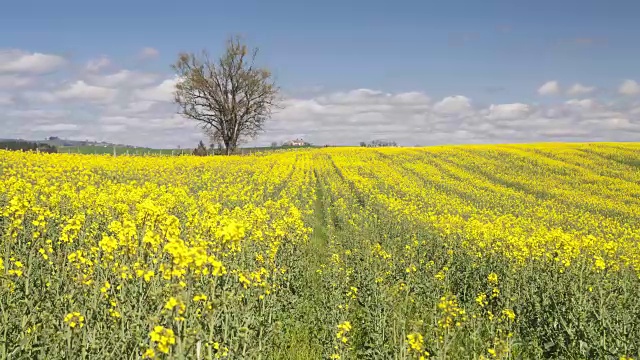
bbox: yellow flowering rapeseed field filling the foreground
[0,143,640,359]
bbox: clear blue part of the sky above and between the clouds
[0,0,640,146]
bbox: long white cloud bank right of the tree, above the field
[264,89,640,145]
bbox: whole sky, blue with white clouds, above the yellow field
[0,0,640,148]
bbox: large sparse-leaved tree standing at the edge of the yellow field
[172,36,279,155]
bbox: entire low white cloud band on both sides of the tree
[0,47,640,148]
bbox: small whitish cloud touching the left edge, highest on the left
[0,50,67,74]
